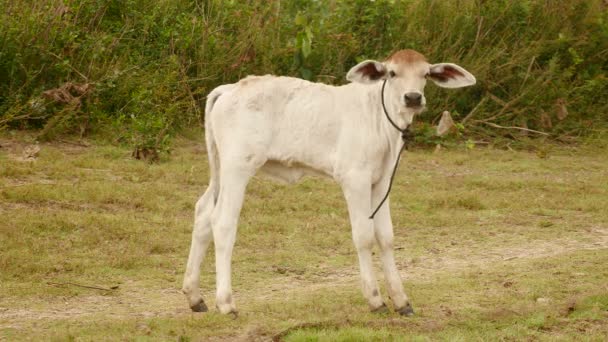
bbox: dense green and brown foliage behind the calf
[0,0,608,149]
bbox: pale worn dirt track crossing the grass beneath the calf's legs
[0,227,608,329]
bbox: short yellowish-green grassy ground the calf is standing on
[0,133,608,341]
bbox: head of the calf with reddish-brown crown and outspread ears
[346,50,476,125]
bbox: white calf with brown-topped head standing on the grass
[183,50,475,315]
